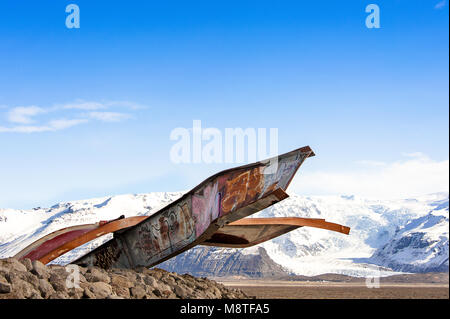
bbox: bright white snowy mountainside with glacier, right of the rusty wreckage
[244,193,449,276]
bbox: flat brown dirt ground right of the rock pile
[222,280,449,299]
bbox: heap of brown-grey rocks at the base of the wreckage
[0,258,249,299]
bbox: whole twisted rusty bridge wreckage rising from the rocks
[15,146,350,269]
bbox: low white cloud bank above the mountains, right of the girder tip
[291,153,449,199]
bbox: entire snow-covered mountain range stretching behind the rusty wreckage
[0,192,449,276]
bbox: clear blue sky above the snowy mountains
[0,0,449,208]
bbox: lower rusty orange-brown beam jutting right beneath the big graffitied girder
[202,217,350,248]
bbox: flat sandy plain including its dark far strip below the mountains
[216,273,449,299]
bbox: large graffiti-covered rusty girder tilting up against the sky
[75,147,314,268]
